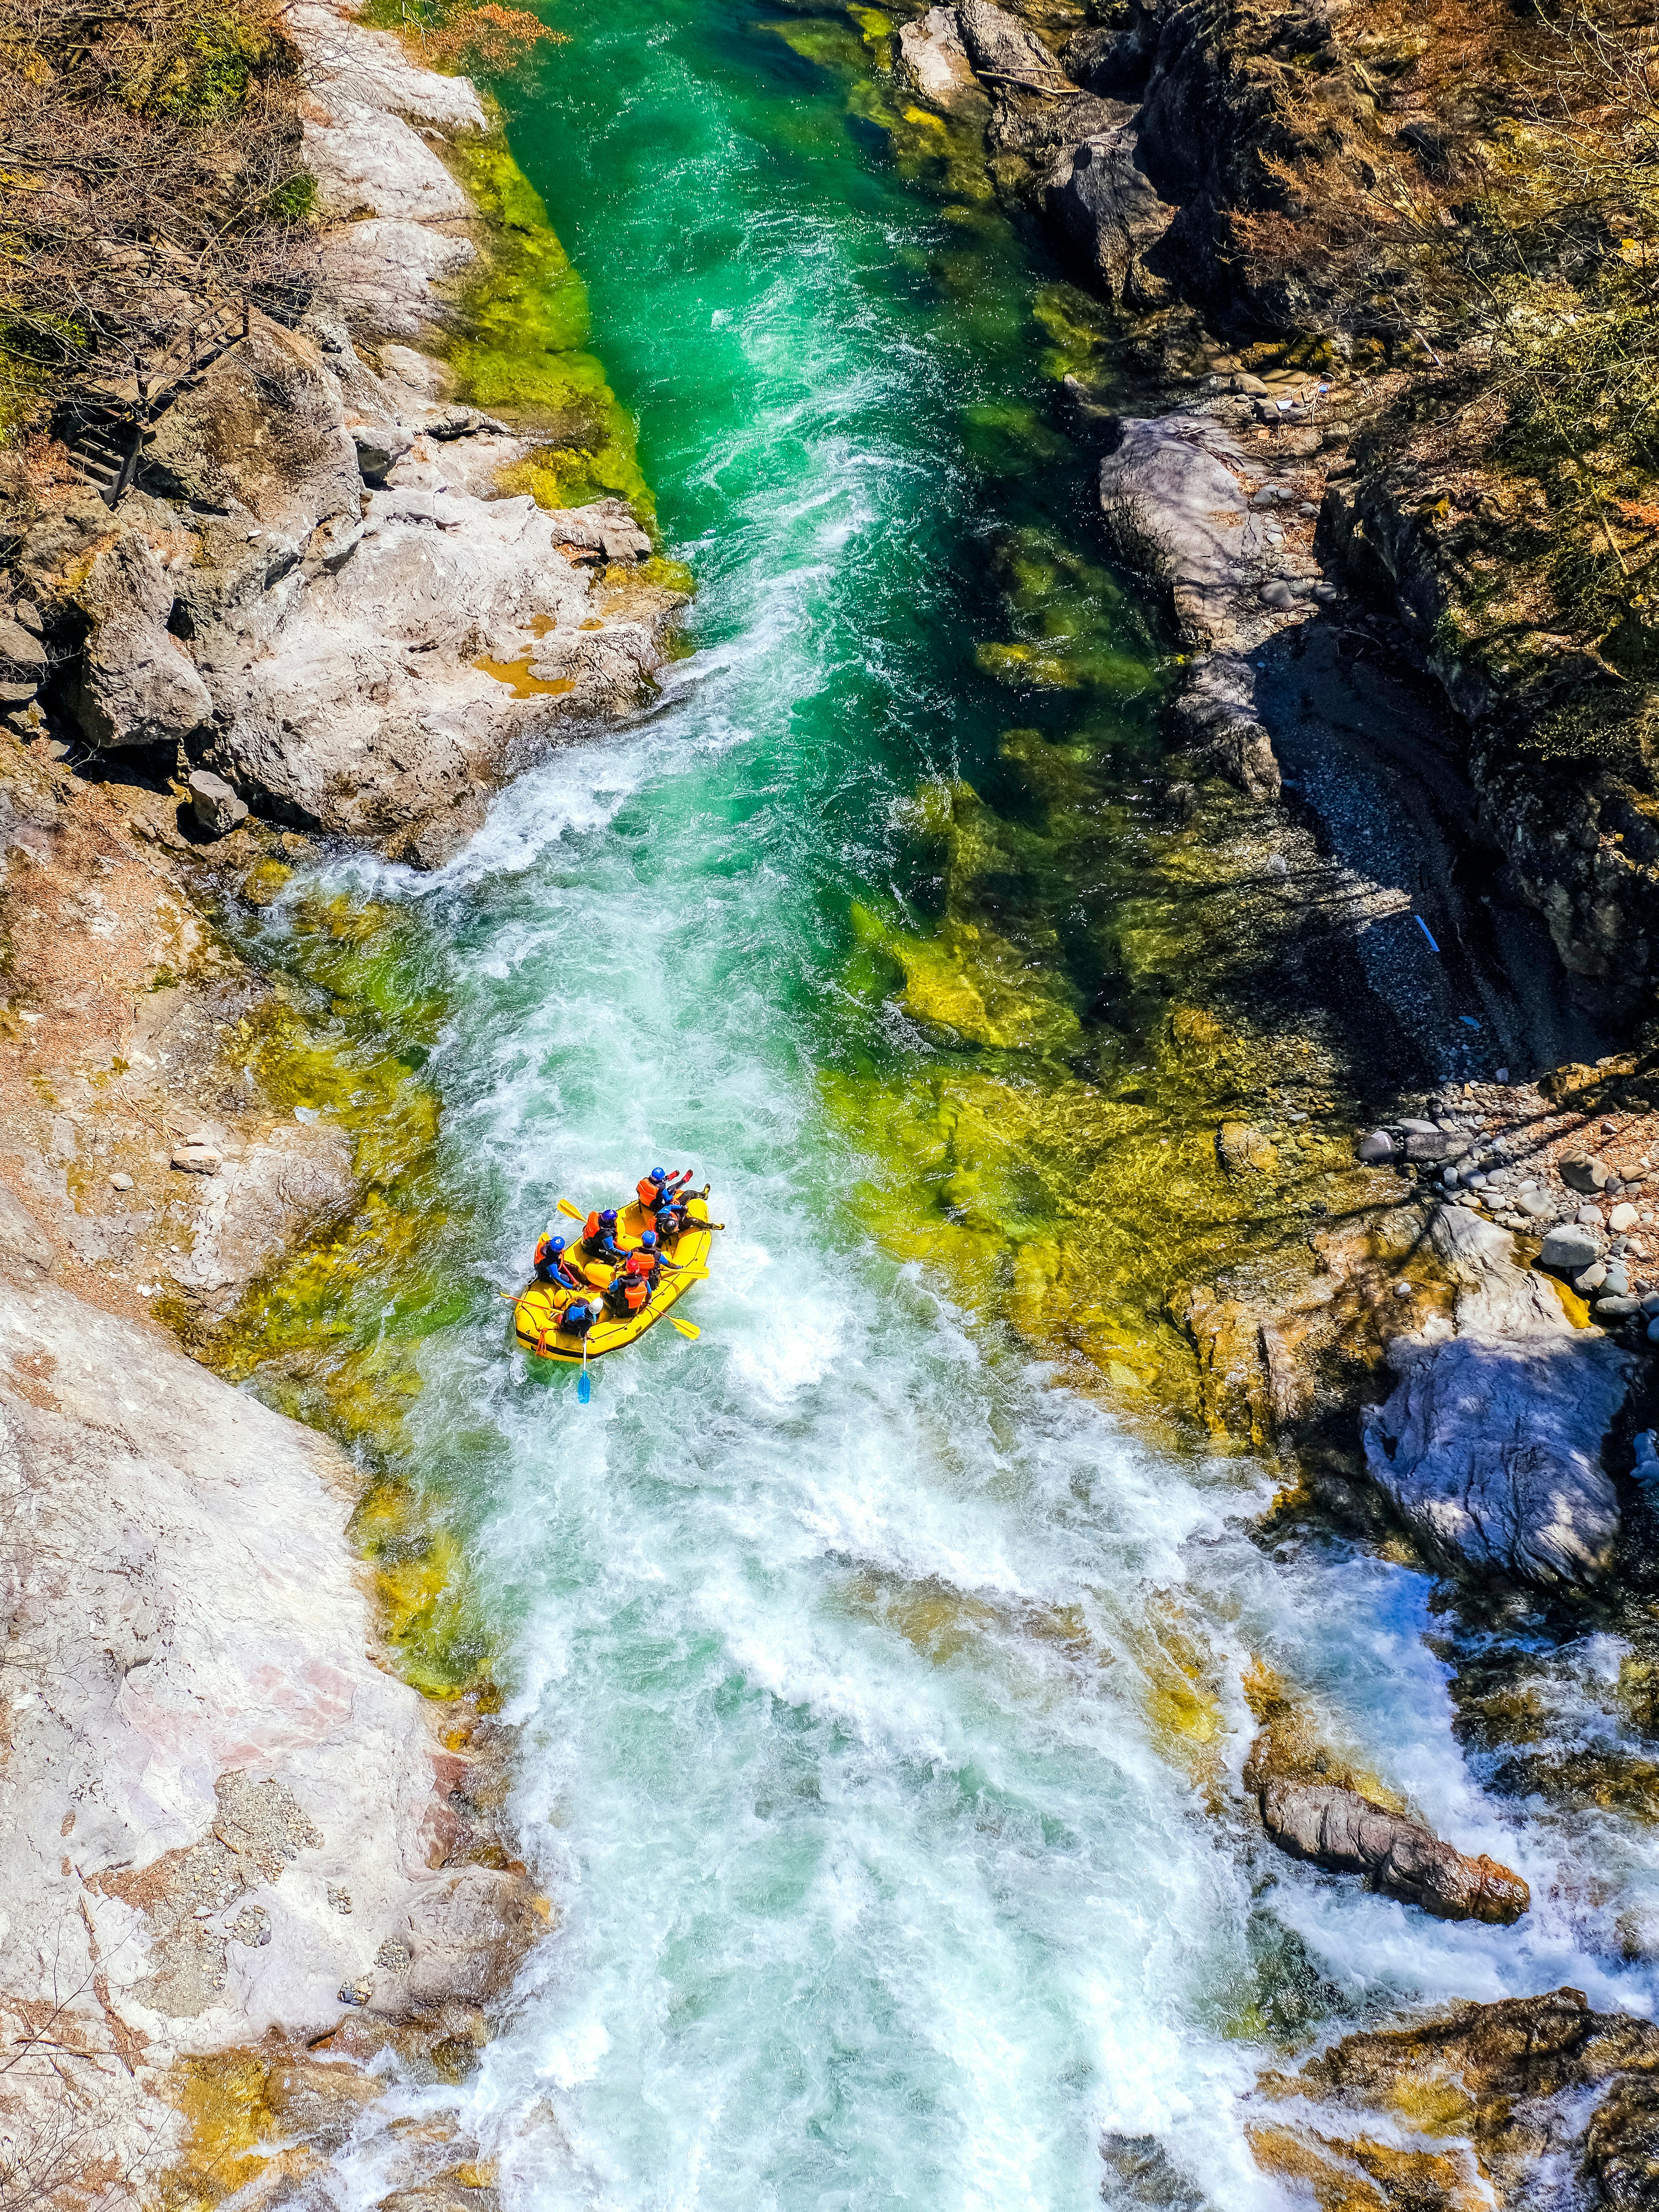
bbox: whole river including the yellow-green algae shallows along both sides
[10,0,1659,2212]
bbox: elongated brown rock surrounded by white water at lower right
[1261,1778,1531,1927]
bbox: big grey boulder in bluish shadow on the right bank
[1365,1205,1630,1588]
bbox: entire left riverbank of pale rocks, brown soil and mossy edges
[0,0,686,2206]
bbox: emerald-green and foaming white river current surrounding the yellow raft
[299,0,1653,2212]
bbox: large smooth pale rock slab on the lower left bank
[0,1236,547,2170]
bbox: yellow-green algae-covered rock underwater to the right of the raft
[823,730,1369,1444]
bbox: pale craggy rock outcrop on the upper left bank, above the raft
[5,0,683,865]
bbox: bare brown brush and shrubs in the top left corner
[0,0,312,438]
